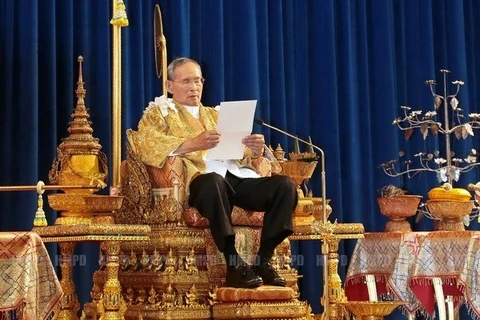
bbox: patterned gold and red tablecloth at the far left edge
[0,232,63,320]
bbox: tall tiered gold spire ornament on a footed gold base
[48,56,108,224]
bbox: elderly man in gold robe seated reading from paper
[127,58,297,288]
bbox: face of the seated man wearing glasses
[167,62,203,106]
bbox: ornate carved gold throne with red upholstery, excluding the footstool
[110,150,298,319]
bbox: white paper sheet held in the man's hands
[207,100,257,160]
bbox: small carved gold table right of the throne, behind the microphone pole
[289,221,365,320]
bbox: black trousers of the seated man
[188,172,298,252]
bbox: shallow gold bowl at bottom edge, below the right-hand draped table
[338,301,405,320]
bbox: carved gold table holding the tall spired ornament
[33,224,150,320]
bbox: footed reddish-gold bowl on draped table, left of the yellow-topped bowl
[377,194,422,232]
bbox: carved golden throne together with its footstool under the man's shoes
[83,146,310,320]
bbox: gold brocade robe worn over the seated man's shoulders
[127,98,260,186]
